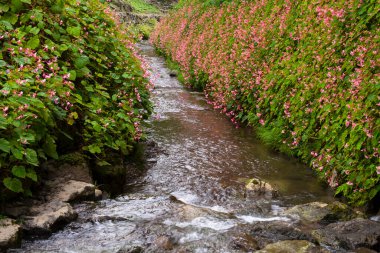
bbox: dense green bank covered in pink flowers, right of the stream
[152,0,380,205]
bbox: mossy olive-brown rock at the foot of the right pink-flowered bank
[284,201,364,224]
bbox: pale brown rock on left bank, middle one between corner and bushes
[23,201,78,235]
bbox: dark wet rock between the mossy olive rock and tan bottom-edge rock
[250,221,316,248]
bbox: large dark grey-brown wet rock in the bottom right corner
[312,218,380,251]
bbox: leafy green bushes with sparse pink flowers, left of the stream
[0,0,151,197]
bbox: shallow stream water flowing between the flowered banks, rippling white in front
[19,42,332,252]
